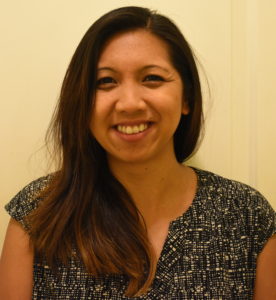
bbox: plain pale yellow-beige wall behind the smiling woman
[0,0,276,247]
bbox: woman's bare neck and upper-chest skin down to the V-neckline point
[110,152,197,261]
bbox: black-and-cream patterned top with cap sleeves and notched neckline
[5,169,276,300]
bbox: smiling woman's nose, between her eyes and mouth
[115,84,146,113]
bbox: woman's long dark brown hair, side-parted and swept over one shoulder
[28,6,202,296]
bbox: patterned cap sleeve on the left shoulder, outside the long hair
[5,173,54,229]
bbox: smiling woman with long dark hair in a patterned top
[0,7,276,299]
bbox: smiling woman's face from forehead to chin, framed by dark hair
[90,29,189,163]
